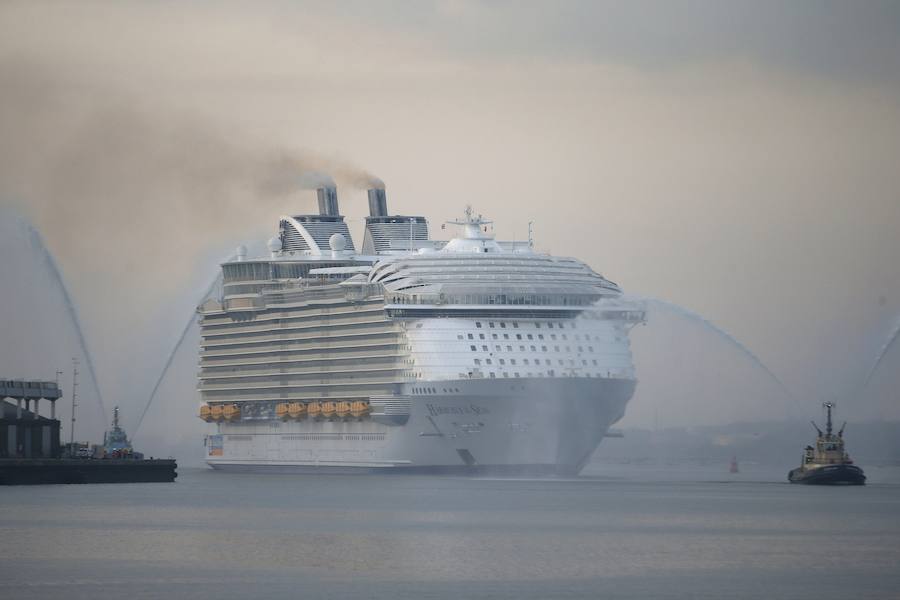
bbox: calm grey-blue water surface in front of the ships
[0,464,900,600]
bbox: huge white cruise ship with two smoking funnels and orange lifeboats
[198,187,645,476]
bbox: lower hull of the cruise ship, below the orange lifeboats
[207,378,635,475]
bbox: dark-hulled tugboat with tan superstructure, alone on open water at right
[788,402,866,485]
